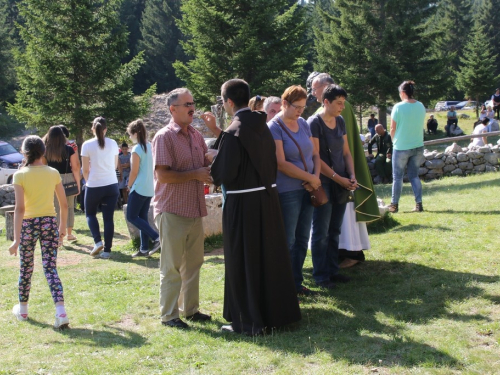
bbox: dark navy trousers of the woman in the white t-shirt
[85,184,120,252]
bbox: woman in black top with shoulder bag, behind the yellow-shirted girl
[43,126,80,241]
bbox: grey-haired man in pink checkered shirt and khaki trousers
[153,88,212,328]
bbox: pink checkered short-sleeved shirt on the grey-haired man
[153,120,209,217]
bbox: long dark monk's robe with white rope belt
[211,109,301,335]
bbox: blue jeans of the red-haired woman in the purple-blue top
[279,189,314,291]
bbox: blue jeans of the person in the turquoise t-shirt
[391,147,424,204]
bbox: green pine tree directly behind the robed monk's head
[174,0,307,105]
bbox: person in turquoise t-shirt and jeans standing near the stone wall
[388,81,425,213]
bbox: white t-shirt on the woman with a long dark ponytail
[82,138,119,187]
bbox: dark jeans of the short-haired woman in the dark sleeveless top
[311,183,347,283]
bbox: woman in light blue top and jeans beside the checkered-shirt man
[127,120,160,258]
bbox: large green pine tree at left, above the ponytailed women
[9,0,154,148]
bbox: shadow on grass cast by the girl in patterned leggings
[27,318,147,348]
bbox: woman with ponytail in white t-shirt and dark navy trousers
[82,117,120,259]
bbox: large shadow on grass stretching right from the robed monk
[193,261,500,370]
